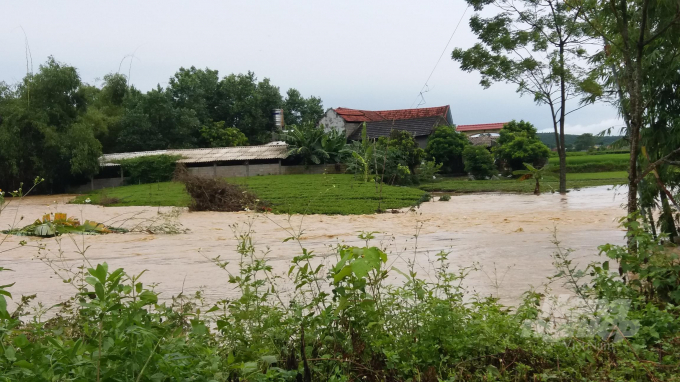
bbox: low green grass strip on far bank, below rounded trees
[420,171,628,193]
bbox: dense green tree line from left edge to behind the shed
[0,57,323,192]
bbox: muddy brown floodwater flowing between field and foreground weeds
[0,187,625,312]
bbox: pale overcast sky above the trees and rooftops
[0,0,622,134]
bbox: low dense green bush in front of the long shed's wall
[118,154,181,184]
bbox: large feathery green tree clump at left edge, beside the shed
[0,57,102,191]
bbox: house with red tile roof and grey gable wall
[319,105,453,147]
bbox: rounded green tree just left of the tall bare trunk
[493,120,550,170]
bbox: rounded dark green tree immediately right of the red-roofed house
[425,126,470,174]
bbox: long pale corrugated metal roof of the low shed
[99,144,288,167]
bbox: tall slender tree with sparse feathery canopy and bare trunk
[452,0,593,193]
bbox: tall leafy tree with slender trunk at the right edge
[574,0,680,233]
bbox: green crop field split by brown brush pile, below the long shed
[74,175,424,215]
